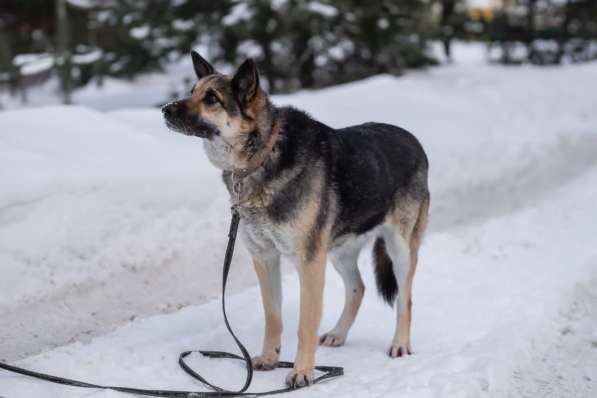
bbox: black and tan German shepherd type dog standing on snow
[162,52,429,387]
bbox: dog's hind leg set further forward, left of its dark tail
[319,246,365,347]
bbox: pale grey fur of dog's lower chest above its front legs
[241,211,299,257]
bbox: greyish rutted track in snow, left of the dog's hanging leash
[0,191,255,361]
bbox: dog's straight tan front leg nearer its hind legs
[286,247,326,387]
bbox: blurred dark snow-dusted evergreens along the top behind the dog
[0,0,597,103]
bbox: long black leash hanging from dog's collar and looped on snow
[0,207,344,398]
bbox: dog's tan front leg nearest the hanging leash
[253,253,282,370]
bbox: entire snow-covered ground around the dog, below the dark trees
[0,47,597,398]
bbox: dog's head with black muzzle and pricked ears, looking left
[162,51,271,169]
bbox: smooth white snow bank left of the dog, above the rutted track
[0,107,251,308]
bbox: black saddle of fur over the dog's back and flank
[332,123,428,236]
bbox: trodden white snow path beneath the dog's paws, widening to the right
[0,160,597,397]
